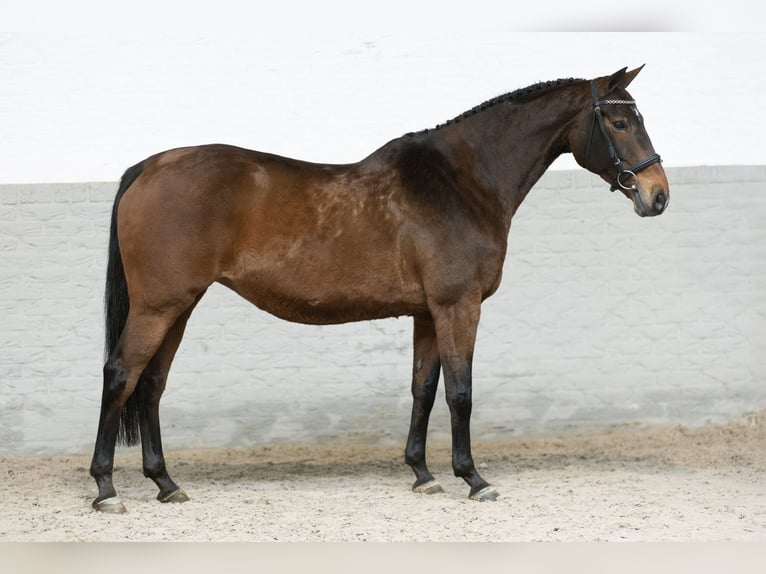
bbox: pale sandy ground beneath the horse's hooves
[0,412,766,542]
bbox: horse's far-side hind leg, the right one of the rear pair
[139,295,202,502]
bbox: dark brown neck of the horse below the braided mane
[440,88,583,229]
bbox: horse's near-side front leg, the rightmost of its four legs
[432,299,498,501]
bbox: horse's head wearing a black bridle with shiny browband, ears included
[569,66,670,217]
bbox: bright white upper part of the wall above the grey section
[0,0,766,183]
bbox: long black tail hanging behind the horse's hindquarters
[104,162,151,445]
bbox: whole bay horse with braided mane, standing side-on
[90,66,669,513]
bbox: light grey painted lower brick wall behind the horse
[0,166,766,453]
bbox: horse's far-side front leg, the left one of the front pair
[404,317,443,494]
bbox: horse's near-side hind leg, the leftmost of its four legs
[90,301,196,513]
